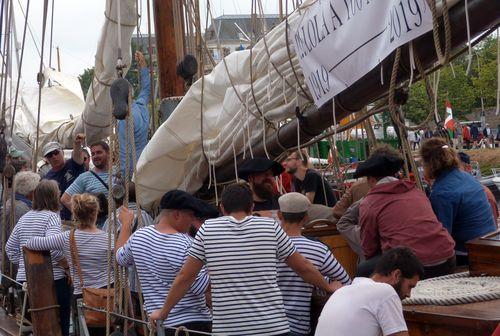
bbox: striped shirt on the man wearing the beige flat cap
[278,236,351,335]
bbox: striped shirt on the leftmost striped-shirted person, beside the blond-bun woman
[5,210,66,282]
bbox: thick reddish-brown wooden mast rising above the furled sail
[153,0,184,99]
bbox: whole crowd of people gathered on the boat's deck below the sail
[3,53,498,336]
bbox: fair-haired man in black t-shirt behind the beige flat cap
[286,150,337,207]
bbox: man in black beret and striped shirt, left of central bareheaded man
[116,190,212,335]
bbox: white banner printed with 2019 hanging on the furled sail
[290,0,432,107]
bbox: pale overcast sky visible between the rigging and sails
[13,0,291,85]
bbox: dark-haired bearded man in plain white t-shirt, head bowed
[315,247,424,336]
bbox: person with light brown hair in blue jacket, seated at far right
[420,138,496,265]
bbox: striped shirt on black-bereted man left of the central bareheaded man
[116,225,212,326]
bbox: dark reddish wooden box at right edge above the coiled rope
[466,230,500,276]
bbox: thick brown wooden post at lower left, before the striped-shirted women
[23,247,61,336]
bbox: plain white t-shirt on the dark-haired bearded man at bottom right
[315,278,408,336]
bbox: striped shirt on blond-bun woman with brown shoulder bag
[26,229,115,295]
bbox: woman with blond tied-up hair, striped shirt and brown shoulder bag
[26,194,114,335]
